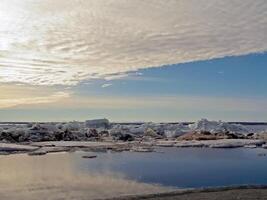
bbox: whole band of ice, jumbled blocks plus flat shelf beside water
[0,119,267,155]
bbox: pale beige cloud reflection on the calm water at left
[0,153,171,200]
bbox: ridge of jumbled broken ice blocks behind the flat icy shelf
[0,119,267,142]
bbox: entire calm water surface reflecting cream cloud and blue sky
[0,148,267,200]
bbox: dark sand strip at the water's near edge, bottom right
[105,186,267,200]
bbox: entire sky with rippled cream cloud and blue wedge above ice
[0,0,267,122]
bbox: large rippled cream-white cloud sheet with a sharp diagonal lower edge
[0,0,267,85]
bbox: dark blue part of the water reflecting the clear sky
[79,148,267,188]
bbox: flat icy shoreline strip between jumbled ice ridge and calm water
[0,139,267,156]
